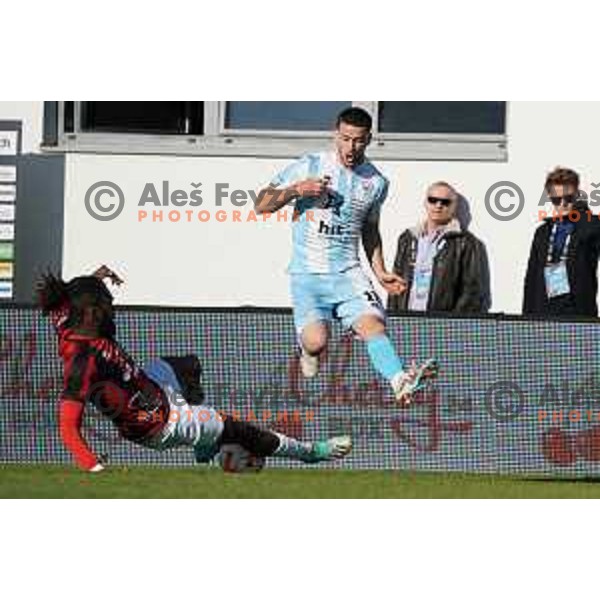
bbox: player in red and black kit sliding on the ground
[38,266,352,473]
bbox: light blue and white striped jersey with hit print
[271,152,388,274]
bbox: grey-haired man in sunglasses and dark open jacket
[388,181,490,313]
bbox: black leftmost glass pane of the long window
[81,102,204,135]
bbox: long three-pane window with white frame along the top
[44,100,507,161]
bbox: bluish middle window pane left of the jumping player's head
[225,100,352,131]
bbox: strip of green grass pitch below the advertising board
[0,465,600,498]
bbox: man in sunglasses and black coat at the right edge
[523,167,600,317]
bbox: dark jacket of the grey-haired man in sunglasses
[388,221,491,313]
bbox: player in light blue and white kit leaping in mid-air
[257,107,437,406]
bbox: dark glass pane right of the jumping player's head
[379,102,506,134]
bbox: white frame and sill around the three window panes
[42,101,510,162]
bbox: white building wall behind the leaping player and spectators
[0,102,600,313]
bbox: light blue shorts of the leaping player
[291,268,385,333]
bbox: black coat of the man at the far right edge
[523,201,600,317]
